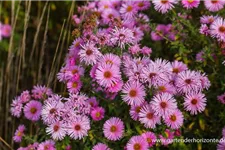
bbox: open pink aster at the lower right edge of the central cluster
[184,92,206,115]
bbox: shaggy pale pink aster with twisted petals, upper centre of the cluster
[110,27,135,49]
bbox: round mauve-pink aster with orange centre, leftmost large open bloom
[23,100,42,121]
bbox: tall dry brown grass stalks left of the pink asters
[0,0,75,149]
